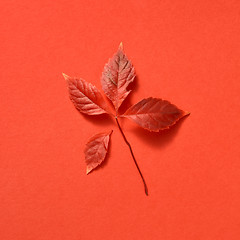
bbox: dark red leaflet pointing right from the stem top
[122,97,188,132]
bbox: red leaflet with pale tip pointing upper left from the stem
[63,73,110,115]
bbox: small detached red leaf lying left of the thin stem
[84,131,112,174]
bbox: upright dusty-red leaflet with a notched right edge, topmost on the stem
[101,43,135,112]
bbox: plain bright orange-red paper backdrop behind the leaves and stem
[0,0,240,240]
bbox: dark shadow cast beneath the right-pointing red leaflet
[129,116,187,148]
